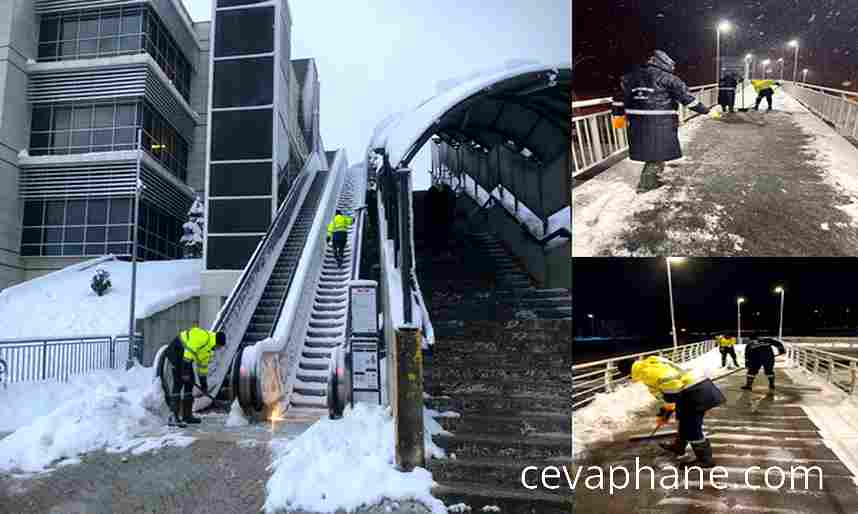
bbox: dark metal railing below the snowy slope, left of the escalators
[0,334,143,383]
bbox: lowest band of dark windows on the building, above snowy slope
[21,198,182,260]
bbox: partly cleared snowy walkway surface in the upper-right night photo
[572,90,858,257]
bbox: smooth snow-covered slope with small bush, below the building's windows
[0,257,203,338]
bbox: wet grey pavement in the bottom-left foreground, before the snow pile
[0,414,309,514]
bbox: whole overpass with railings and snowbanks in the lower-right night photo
[570,337,858,514]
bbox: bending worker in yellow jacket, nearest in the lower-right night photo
[632,356,725,467]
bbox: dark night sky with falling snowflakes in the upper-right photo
[572,0,858,98]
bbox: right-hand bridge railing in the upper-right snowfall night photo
[784,82,858,138]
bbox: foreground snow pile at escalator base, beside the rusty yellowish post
[265,403,447,514]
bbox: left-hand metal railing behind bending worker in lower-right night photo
[572,339,718,410]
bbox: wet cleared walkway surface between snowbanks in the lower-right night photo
[572,369,858,514]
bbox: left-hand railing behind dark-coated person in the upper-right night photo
[572,84,718,177]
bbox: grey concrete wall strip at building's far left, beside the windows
[0,0,36,289]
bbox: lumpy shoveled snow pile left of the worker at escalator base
[0,366,193,472]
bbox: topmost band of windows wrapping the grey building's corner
[39,6,191,100]
